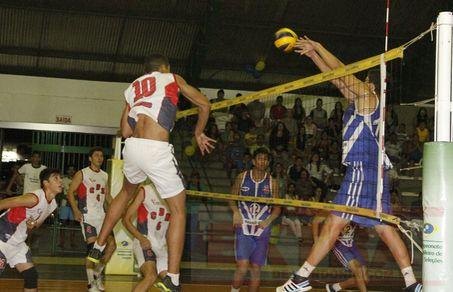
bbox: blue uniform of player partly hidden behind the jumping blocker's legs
[332,223,366,269]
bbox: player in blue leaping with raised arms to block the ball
[276,38,422,292]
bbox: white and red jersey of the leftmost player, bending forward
[0,189,57,245]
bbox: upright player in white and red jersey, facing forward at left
[66,147,116,292]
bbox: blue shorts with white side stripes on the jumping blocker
[332,162,392,227]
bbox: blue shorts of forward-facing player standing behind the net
[234,228,270,267]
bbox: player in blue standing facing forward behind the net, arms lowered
[230,148,280,292]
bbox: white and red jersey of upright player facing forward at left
[77,167,108,217]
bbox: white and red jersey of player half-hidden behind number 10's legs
[137,185,170,248]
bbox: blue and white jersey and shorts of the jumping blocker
[332,99,392,227]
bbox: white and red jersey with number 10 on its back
[124,71,179,131]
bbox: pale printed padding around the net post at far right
[422,142,453,292]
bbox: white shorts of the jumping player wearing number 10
[123,137,184,199]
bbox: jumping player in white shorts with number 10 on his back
[88,54,215,291]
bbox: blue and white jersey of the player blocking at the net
[342,103,392,169]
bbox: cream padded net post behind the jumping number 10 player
[105,159,135,275]
